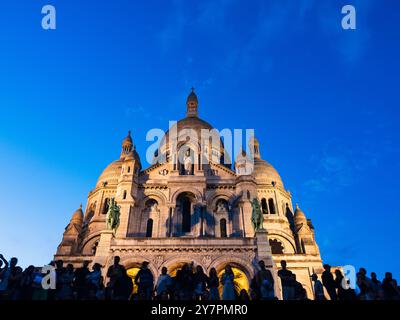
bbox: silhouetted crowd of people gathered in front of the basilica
[0,255,400,301]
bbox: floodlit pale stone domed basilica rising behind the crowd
[55,90,322,299]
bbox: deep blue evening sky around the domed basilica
[0,0,400,277]
